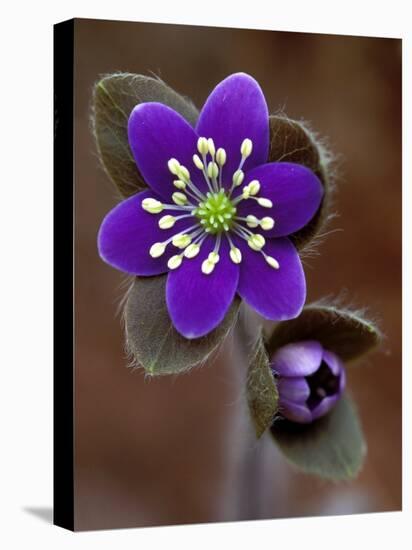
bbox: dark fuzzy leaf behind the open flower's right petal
[269,115,332,253]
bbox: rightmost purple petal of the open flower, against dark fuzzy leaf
[237,162,323,237]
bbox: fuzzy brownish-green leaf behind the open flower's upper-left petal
[92,73,198,198]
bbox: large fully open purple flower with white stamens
[98,73,323,338]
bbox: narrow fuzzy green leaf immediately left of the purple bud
[246,336,278,438]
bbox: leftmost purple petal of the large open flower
[97,191,190,275]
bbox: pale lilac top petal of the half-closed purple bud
[271,340,323,380]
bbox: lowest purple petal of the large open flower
[166,237,239,338]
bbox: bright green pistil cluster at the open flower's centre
[194,189,236,235]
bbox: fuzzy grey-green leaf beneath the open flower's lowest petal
[124,275,240,376]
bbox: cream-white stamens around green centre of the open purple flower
[141,137,279,275]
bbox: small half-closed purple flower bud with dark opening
[271,340,346,424]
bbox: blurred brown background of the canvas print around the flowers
[75,20,401,529]
